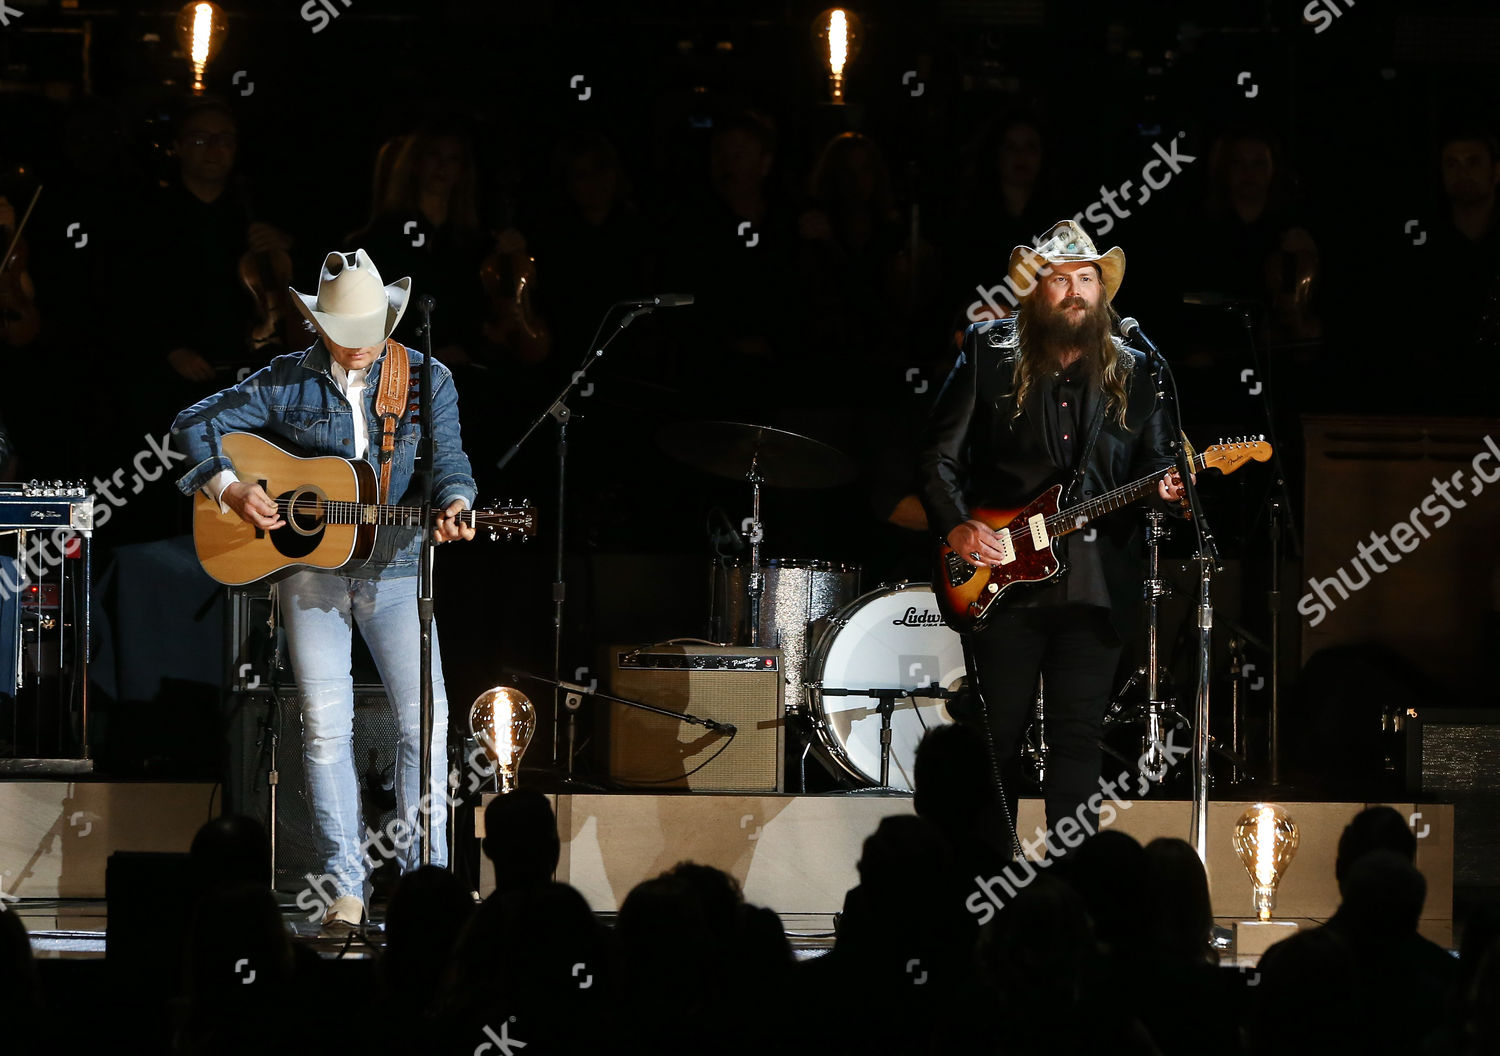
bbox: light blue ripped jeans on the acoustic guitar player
[278,570,449,900]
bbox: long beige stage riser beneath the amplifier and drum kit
[476,794,1454,920]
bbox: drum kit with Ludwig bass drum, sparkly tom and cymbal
[657,422,968,792]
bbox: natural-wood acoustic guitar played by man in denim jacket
[192,432,537,587]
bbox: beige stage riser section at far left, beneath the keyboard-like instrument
[0,782,219,899]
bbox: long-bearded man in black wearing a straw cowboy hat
[918,221,1182,855]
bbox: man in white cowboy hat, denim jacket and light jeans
[173,249,476,930]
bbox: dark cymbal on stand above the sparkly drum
[657,422,855,488]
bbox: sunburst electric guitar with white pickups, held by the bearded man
[933,441,1271,633]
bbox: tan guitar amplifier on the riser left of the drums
[605,645,785,792]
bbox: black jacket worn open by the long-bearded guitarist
[918,318,1176,633]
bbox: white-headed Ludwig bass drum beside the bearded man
[806,584,968,791]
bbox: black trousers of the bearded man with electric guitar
[969,605,1122,857]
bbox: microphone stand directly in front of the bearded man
[1136,330,1218,869]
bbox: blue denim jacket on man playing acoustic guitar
[173,341,477,579]
